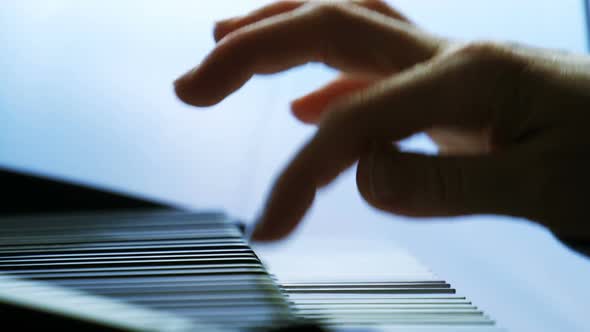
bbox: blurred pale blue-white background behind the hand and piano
[0,0,590,331]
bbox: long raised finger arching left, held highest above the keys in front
[175,5,442,106]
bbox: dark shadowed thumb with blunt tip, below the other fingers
[357,145,531,217]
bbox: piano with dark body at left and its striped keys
[0,171,499,332]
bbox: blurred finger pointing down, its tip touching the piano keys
[252,69,430,241]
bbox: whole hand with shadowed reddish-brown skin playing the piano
[175,0,590,241]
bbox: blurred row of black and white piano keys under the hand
[0,211,506,332]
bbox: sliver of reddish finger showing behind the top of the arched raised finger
[214,0,410,41]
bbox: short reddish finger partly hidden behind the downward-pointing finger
[291,76,373,124]
